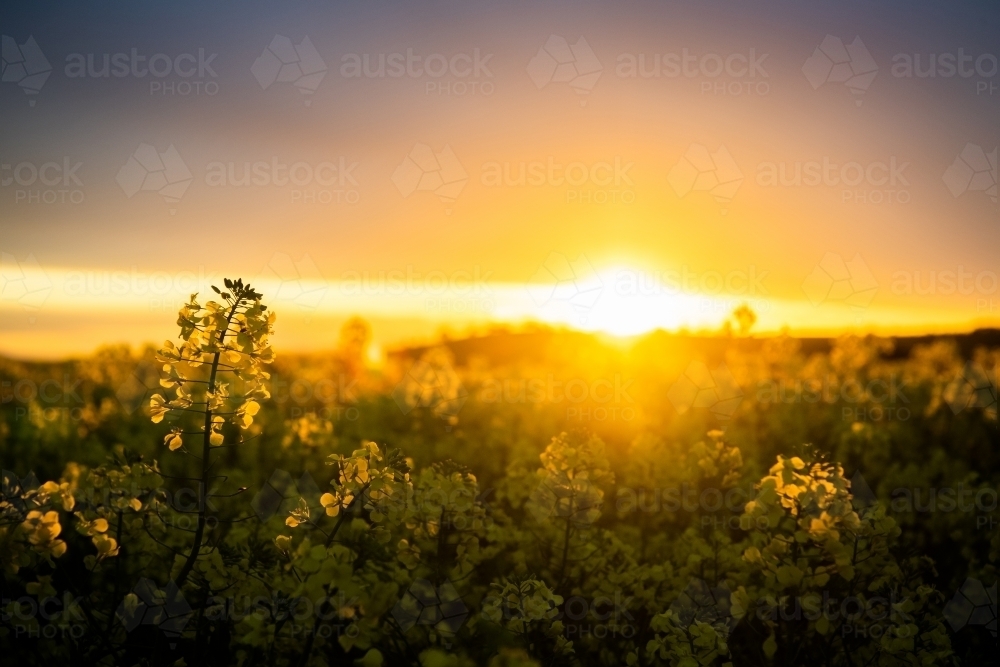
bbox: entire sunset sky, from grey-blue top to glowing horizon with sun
[0,0,1000,357]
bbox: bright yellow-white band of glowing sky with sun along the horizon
[0,263,995,358]
